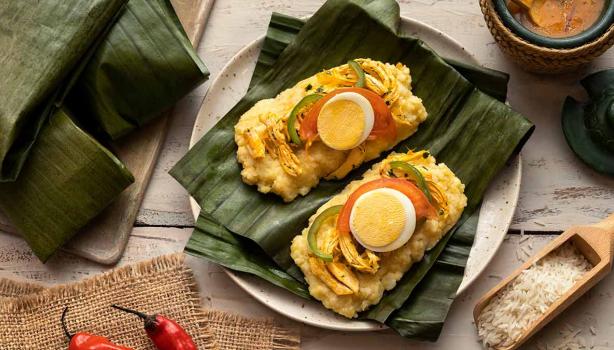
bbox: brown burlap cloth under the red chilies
[0,254,300,350]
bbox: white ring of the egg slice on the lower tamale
[350,188,416,252]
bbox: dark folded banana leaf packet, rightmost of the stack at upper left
[65,0,209,139]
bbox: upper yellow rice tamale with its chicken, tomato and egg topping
[235,58,427,202]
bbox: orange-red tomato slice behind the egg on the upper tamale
[299,87,397,142]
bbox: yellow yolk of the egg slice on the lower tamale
[351,191,407,247]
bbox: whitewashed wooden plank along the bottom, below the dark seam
[0,231,614,350]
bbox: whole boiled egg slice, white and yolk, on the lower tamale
[350,188,416,252]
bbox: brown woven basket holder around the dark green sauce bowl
[480,0,614,73]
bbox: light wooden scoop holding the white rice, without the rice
[473,214,614,350]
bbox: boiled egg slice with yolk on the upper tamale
[318,92,375,151]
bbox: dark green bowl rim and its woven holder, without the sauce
[480,0,614,73]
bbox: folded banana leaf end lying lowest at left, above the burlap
[0,110,134,261]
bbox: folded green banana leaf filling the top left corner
[0,0,126,182]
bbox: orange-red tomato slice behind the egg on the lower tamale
[337,178,437,234]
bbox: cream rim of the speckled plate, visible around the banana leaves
[189,16,522,332]
